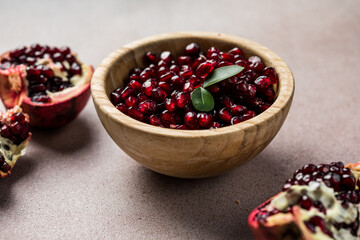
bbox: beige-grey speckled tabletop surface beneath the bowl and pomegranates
[0,0,360,239]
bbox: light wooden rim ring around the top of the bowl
[91,32,295,138]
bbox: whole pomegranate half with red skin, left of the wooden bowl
[0,44,94,128]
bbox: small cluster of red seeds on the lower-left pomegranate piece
[0,112,29,145]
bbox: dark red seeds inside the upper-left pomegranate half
[0,44,82,103]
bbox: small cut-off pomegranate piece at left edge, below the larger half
[0,106,31,177]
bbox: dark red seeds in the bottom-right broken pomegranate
[255,162,360,237]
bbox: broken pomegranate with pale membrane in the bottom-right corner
[248,162,360,240]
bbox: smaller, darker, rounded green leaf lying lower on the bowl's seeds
[191,87,215,112]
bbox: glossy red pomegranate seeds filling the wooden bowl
[110,43,278,130]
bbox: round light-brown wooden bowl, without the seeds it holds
[91,32,294,178]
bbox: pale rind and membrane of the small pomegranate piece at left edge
[0,106,31,178]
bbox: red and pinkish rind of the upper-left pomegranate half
[0,52,94,128]
